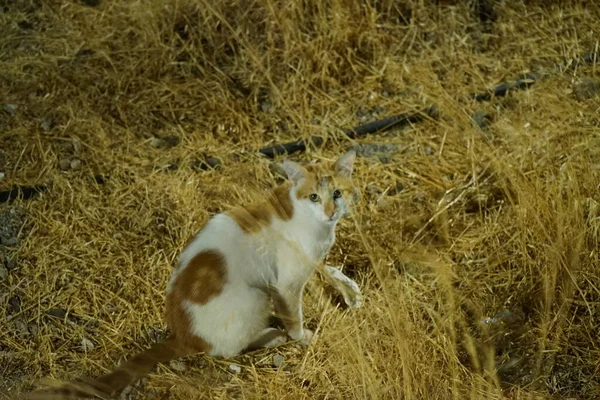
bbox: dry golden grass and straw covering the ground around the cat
[0,0,600,399]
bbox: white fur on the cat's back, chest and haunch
[167,153,354,357]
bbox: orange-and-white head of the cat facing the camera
[282,150,358,223]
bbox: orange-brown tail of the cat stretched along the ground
[27,337,190,400]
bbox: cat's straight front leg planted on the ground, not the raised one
[271,286,313,345]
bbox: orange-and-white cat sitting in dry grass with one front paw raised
[30,150,361,399]
